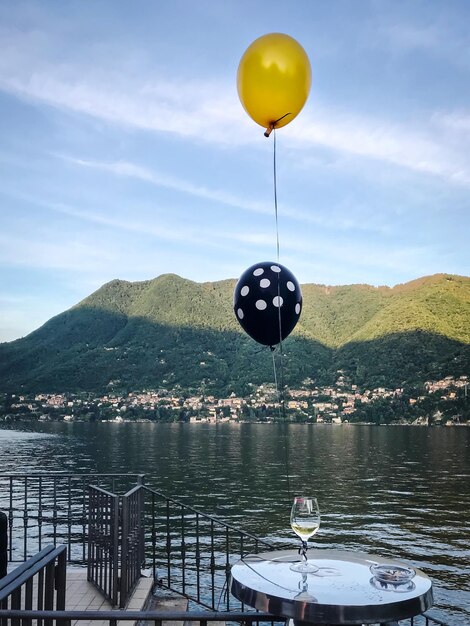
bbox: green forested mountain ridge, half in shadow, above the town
[0,274,470,394]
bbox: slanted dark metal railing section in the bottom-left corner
[0,546,66,626]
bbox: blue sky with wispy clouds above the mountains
[0,0,470,341]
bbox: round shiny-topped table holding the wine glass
[231,550,433,625]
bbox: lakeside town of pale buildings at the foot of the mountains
[0,371,470,426]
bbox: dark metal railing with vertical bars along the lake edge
[0,474,280,610]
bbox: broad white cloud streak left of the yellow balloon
[0,24,246,145]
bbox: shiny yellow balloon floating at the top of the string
[237,33,312,129]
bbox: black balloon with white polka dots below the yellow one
[233,261,302,346]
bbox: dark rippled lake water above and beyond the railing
[0,423,470,625]
